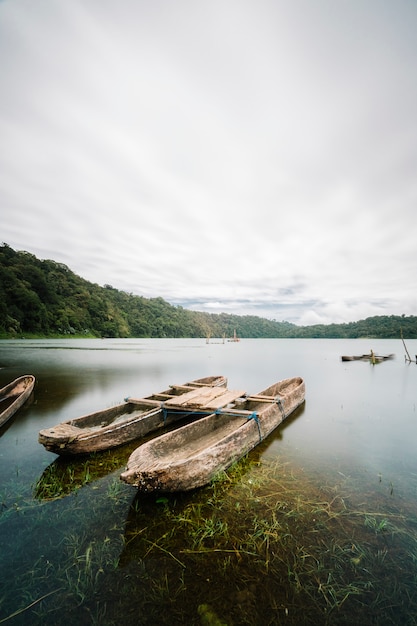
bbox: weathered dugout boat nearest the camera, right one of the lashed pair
[120,377,305,492]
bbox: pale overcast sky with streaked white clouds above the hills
[0,0,417,325]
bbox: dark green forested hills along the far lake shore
[0,244,417,338]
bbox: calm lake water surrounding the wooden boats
[0,339,417,626]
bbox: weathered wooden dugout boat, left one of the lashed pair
[39,376,227,454]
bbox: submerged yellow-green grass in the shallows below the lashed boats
[0,446,417,626]
